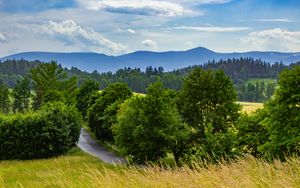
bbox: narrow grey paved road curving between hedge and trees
[77,128,126,164]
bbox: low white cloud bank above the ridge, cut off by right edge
[242,28,300,51]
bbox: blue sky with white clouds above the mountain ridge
[0,0,300,57]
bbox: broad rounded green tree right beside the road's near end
[114,83,190,163]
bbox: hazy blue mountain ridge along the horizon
[0,47,300,72]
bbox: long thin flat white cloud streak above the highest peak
[172,26,251,32]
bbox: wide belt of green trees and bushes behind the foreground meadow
[0,62,300,165]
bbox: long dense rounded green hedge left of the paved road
[0,103,82,160]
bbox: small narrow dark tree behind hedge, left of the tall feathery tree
[12,78,31,113]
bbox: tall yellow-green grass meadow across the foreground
[0,150,300,188]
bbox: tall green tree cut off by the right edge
[260,66,300,159]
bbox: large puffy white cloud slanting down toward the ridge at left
[41,20,127,55]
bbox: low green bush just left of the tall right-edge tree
[237,109,268,157]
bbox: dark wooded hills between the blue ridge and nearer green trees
[0,58,299,102]
